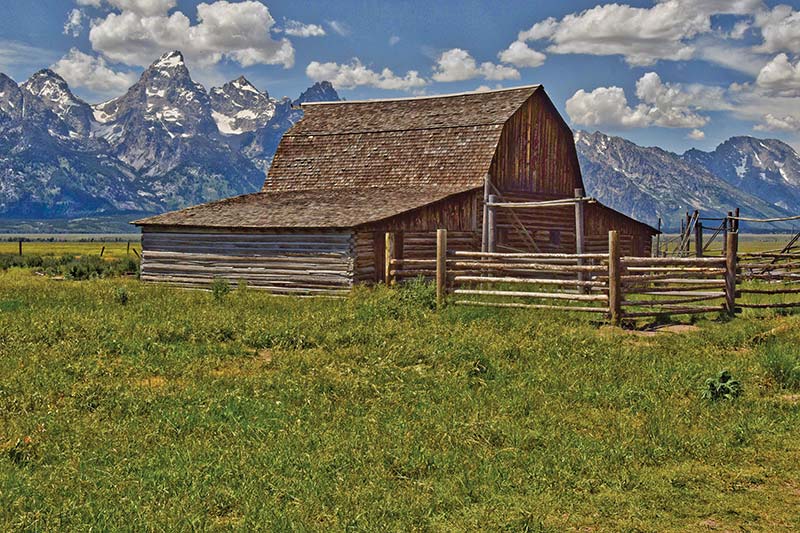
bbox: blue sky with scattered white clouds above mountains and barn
[0,0,800,152]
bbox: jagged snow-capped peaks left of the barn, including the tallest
[0,47,338,218]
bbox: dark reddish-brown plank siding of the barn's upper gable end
[489,91,583,197]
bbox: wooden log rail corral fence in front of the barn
[385,230,800,325]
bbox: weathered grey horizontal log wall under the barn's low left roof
[142,228,355,293]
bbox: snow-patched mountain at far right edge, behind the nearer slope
[683,137,800,210]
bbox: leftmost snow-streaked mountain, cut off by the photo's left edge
[0,73,152,218]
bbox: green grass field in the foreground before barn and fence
[0,269,800,531]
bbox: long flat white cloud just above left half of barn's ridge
[306,58,428,91]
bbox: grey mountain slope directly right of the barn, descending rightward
[575,131,800,229]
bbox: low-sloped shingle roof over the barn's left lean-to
[132,187,468,229]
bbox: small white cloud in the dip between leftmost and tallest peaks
[50,48,137,95]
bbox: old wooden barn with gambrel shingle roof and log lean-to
[133,85,657,293]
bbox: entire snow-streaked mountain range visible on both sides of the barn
[0,51,800,230]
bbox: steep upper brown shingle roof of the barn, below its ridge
[262,85,539,191]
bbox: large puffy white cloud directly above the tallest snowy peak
[89,0,294,68]
